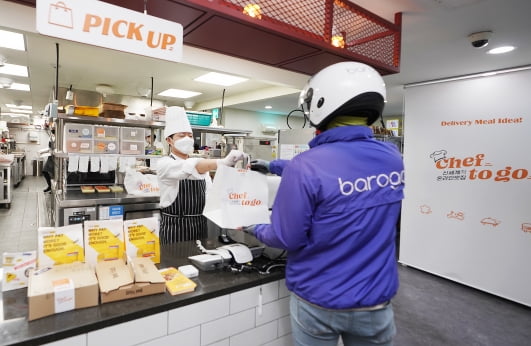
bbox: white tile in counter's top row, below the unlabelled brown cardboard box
[87,312,168,346]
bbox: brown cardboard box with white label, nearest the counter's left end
[28,262,98,321]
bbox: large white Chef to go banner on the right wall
[399,70,531,306]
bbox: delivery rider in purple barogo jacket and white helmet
[247,62,404,346]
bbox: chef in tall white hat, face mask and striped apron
[157,107,245,244]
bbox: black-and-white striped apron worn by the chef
[160,179,208,244]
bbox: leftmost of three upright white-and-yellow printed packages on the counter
[37,224,85,268]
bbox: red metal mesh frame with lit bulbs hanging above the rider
[222,0,401,71]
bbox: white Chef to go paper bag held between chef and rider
[203,165,270,229]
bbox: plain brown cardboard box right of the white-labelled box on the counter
[96,257,166,303]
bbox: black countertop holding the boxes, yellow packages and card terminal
[0,239,284,345]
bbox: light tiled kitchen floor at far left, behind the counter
[0,176,50,254]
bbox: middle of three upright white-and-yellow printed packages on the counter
[84,220,125,266]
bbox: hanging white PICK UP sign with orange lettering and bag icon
[36,0,183,62]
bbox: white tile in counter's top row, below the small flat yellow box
[168,295,230,334]
